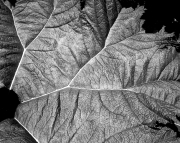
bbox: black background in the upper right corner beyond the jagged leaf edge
[119,0,180,39]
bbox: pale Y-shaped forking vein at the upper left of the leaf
[9,6,56,90]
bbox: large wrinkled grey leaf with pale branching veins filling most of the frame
[0,0,180,143]
